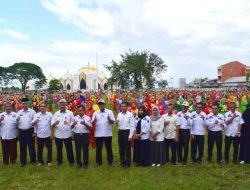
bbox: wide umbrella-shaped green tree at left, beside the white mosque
[4,62,46,93]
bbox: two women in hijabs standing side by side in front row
[134,106,166,167]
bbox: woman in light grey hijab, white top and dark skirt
[150,106,166,167]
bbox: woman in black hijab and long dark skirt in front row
[134,106,150,166]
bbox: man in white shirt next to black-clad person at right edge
[225,102,244,164]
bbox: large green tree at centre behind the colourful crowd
[104,50,167,89]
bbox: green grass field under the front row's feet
[0,97,250,190]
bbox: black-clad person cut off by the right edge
[240,103,250,164]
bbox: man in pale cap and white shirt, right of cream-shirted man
[177,102,192,165]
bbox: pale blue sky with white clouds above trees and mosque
[0,0,250,86]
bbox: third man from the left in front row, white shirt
[32,102,53,166]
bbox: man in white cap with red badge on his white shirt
[51,99,75,167]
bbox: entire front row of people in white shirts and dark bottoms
[0,98,246,168]
